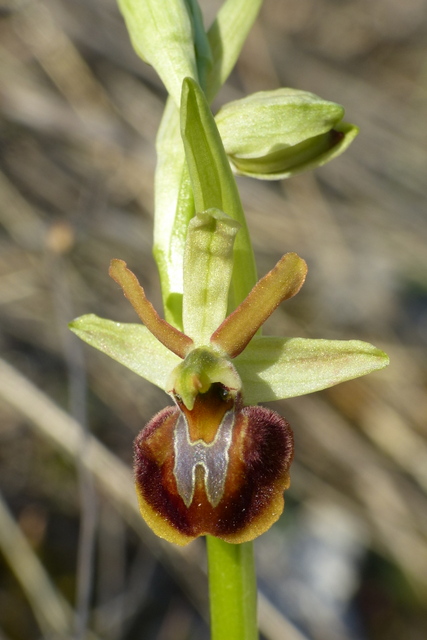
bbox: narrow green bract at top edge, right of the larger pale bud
[206,0,262,102]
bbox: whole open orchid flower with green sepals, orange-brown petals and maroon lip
[70,209,388,545]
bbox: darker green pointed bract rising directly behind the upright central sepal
[181,78,257,306]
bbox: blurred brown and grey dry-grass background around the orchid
[0,0,427,640]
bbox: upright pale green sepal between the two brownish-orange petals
[183,209,240,346]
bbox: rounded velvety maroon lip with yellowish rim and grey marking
[135,384,293,545]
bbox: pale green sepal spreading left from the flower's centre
[69,314,182,390]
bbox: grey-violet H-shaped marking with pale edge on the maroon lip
[173,408,235,508]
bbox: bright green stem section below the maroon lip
[206,536,258,640]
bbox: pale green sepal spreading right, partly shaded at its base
[233,337,389,404]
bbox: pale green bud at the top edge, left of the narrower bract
[118,0,197,106]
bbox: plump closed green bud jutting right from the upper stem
[216,89,358,180]
